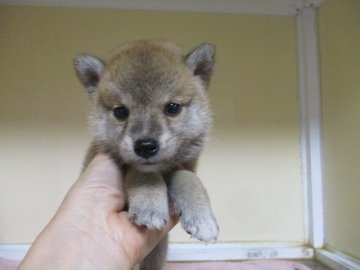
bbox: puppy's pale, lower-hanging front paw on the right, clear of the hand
[180,213,219,243]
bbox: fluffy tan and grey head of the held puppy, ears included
[74,41,215,172]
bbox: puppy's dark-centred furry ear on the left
[74,54,105,93]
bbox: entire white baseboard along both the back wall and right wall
[0,243,360,270]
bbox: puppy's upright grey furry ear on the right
[185,43,215,85]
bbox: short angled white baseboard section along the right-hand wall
[315,249,360,270]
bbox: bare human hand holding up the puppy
[18,154,178,270]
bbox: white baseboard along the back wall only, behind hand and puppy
[0,243,314,261]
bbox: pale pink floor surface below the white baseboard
[0,257,330,270]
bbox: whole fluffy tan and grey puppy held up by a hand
[74,40,218,270]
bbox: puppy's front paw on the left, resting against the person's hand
[129,206,169,229]
